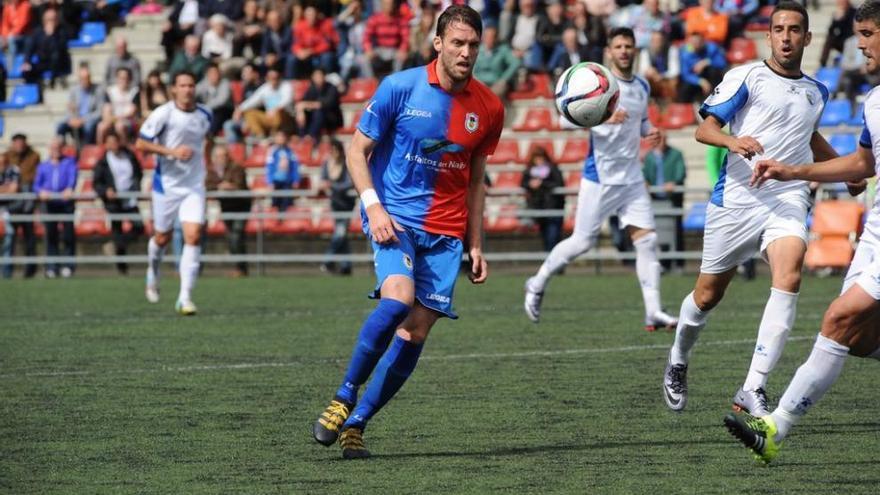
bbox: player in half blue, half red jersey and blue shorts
[313,6,504,459]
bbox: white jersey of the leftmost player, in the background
[140,101,212,193]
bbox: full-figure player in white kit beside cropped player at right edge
[663,1,860,416]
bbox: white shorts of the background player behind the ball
[574,178,654,239]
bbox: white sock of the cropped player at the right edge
[770,334,849,441]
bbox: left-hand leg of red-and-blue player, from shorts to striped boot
[313,231,415,446]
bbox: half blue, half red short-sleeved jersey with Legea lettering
[358,61,504,239]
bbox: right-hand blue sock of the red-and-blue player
[345,336,424,429]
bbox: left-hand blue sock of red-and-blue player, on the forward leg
[336,299,410,404]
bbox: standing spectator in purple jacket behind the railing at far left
[34,136,77,278]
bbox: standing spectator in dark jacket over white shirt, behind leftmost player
[93,132,144,275]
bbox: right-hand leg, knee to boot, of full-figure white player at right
[733,236,807,417]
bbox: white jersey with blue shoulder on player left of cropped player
[700,62,828,208]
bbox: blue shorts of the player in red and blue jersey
[372,227,463,319]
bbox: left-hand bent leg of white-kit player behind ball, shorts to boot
[525,179,605,323]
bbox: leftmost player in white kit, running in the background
[135,71,212,315]
